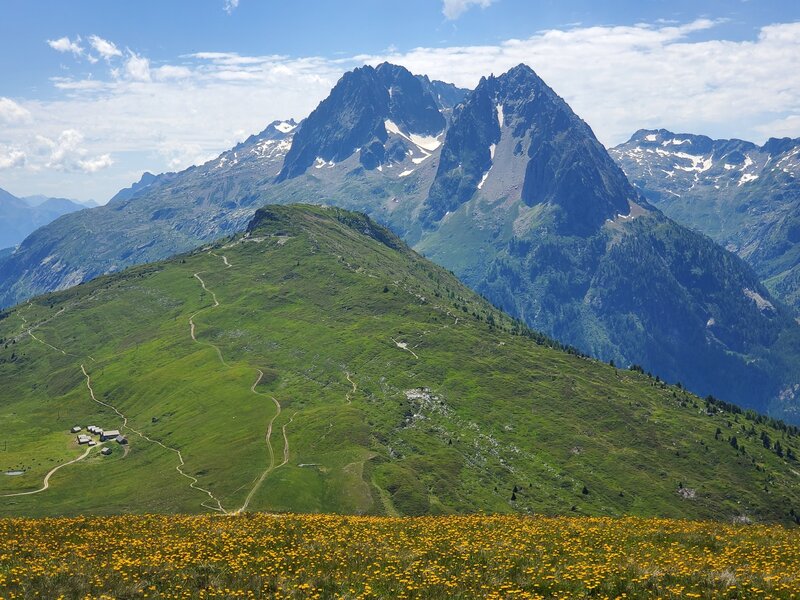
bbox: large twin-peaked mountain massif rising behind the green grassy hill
[0,63,800,420]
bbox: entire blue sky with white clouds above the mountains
[0,0,800,202]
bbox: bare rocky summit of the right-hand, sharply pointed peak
[424,64,637,233]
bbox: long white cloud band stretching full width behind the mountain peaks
[0,19,800,199]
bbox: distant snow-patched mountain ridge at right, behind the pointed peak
[610,129,800,310]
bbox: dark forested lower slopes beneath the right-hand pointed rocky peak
[416,199,800,423]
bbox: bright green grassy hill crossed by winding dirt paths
[0,206,800,522]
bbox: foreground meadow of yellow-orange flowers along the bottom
[0,514,800,599]
